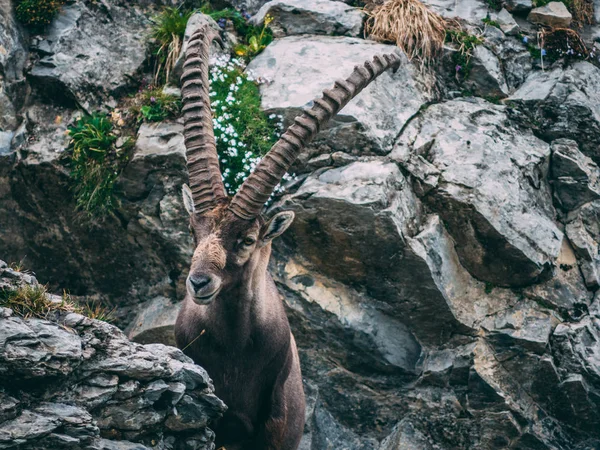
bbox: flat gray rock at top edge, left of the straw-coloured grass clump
[252,0,365,37]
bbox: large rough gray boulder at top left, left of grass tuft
[30,0,150,111]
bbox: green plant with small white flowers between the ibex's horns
[210,57,281,194]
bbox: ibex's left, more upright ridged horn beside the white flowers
[181,25,227,213]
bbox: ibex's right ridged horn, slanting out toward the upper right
[229,53,400,220]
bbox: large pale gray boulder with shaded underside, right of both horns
[392,100,562,286]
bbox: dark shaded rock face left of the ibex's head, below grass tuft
[0,118,192,324]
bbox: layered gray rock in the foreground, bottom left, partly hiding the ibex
[0,262,226,450]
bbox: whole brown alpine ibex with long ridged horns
[175,26,400,450]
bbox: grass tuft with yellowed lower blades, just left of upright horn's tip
[152,8,194,84]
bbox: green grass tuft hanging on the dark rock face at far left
[66,114,133,217]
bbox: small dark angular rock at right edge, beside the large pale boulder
[551,139,600,211]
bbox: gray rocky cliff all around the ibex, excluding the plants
[0,0,600,450]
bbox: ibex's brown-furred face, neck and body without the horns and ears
[175,208,305,450]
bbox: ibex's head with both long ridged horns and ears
[181,26,400,304]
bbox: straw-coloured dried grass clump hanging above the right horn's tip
[365,0,448,64]
